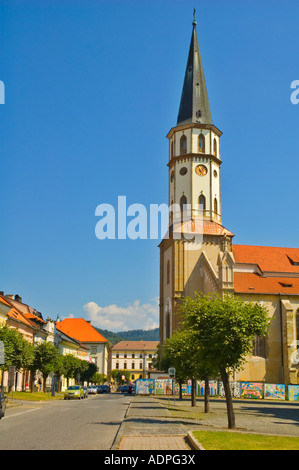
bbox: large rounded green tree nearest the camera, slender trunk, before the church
[181,293,270,428]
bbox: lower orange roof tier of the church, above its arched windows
[234,273,299,295]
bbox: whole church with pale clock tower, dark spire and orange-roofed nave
[159,18,299,385]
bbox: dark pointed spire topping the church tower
[177,10,213,125]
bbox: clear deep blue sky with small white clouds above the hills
[0,0,299,331]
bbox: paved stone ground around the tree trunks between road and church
[112,395,299,451]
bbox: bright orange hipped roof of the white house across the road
[56,318,107,343]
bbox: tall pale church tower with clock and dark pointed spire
[160,18,234,343]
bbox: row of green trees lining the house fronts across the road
[0,325,101,391]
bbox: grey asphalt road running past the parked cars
[0,394,130,450]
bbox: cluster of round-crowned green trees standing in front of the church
[155,293,270,428]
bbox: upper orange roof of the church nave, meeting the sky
[233,245,299,274]
